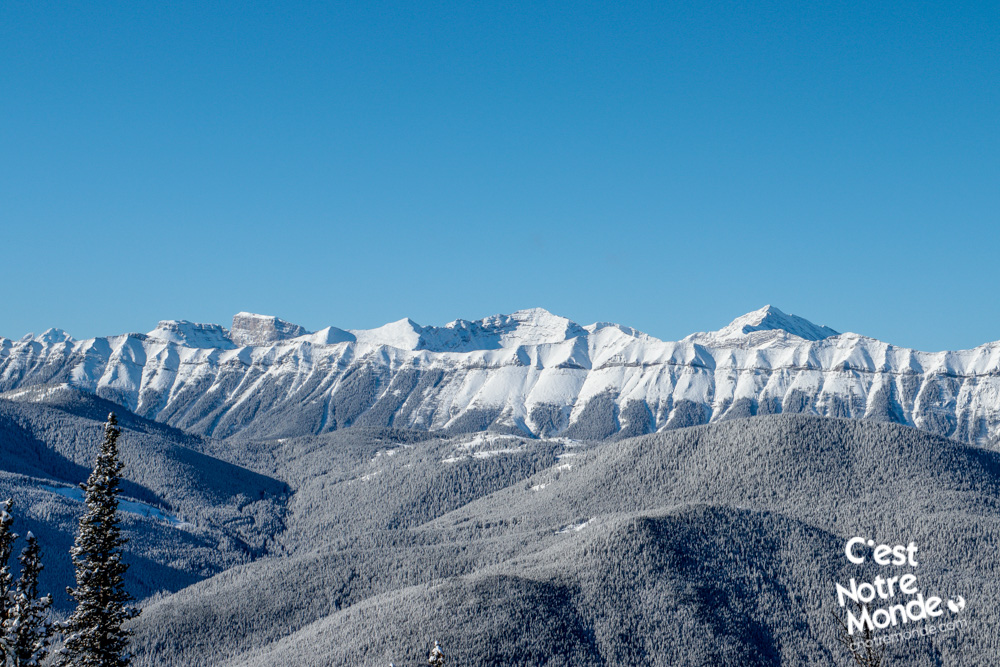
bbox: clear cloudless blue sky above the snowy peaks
[0,0,1000,349]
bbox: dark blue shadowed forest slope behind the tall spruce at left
[0,397,289,610]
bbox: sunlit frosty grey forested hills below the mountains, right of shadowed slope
[123,416,1000,665]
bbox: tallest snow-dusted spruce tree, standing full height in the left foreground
[56,413,139,667]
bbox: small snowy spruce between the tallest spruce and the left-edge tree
[3,532,52,667]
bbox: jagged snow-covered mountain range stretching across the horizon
[0,306,1000,446]
